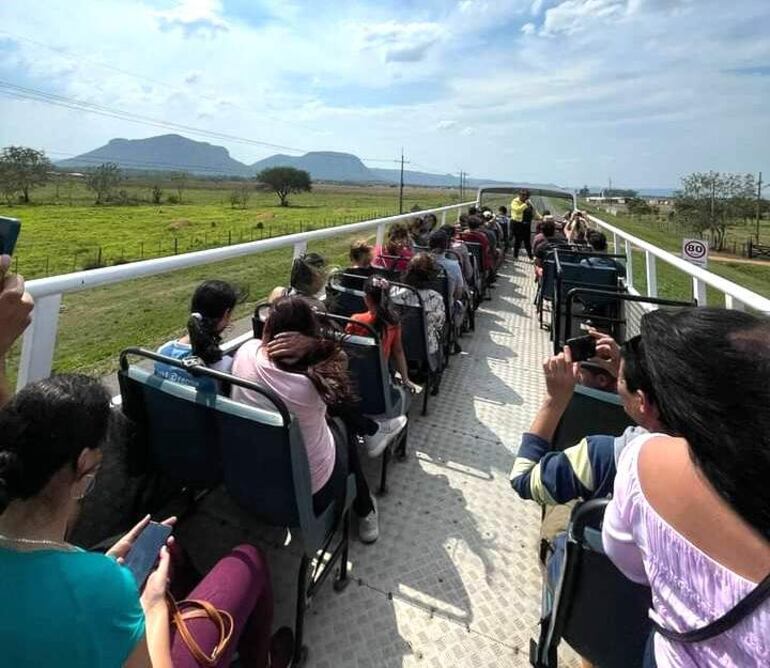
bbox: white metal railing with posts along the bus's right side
[588,216,770,314]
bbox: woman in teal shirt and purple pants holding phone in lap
[0,375,293,668]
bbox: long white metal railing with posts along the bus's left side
[17,201,476,388]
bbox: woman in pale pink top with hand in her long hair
[232,295,379,543]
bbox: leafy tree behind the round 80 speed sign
[674,172,756,250]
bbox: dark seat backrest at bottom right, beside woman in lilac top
[554,499,652,668]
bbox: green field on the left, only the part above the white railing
[6,181,457,279]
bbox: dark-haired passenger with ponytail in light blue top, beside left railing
[155,281,243,393]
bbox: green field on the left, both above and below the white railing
[0,184,457,374]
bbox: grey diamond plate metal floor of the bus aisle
[179,260,577,668]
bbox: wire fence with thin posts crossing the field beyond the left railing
[14,211,397,279]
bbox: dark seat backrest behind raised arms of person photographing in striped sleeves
[551,385,634,450]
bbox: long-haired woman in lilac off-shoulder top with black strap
[603,308,770,668]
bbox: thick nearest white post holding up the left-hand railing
[16,294,61,390]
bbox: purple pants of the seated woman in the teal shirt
[171,545,273,668]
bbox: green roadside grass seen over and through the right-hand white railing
[581,205,770,305]
